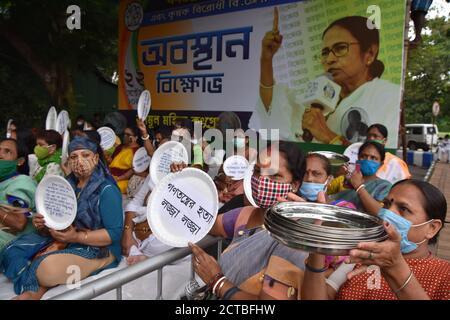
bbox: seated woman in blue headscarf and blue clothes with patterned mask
[2,137,123,299]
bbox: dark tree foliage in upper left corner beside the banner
[0,0,118,120]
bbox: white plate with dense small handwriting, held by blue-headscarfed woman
[36,175,77,230]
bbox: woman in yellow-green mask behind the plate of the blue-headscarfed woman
[30,130,64,183]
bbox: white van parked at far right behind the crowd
[405,123,438,151]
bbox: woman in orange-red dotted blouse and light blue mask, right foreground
[302,180,450,300]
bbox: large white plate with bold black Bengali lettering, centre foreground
[147,168,219,247]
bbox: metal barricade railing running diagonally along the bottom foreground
[50,236,222,300]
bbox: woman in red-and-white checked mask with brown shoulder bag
[185,141,306,300]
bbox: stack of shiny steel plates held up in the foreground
[264,202,387,256]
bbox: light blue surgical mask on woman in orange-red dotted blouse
[378,208,434,253]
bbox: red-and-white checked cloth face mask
[252,176,292,208]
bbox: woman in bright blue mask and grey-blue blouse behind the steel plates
[328,141,391,214]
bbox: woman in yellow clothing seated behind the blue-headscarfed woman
[109,127,142,194]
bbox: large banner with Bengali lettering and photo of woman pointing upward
[119,0,406,149]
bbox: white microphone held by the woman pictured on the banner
[301,73,341,142]
